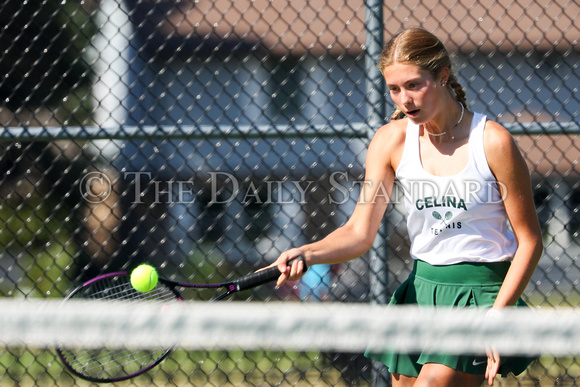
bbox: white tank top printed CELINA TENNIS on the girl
[396,113,517,265]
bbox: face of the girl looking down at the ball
[383,63,445,124]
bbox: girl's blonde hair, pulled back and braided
[378,28,467,120]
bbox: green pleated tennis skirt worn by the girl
[365,260,535,376]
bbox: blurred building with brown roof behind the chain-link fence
[95,0,580,298]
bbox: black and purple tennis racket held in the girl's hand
[56,257,307,383]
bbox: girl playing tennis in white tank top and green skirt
[273,28,542,387]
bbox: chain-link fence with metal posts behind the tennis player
[0,0,580,386]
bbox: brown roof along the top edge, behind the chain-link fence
[128,0,580,56]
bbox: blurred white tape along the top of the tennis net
[0,300,580,356]
